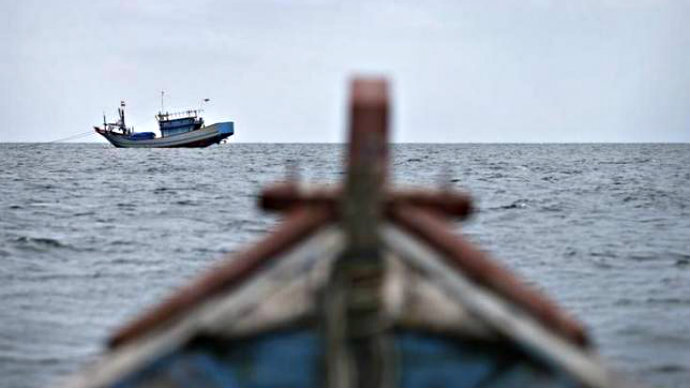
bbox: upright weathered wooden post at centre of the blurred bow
[322,79,394,388]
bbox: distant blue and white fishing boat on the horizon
[94,99,235,148]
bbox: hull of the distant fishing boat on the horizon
[96,121,234,148]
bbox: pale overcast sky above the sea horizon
[0,0,690,142]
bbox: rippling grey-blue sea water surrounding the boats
[0,144,690,387]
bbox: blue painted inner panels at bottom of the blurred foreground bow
[110,330,580,388]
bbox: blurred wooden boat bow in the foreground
[64,79,621,388]
